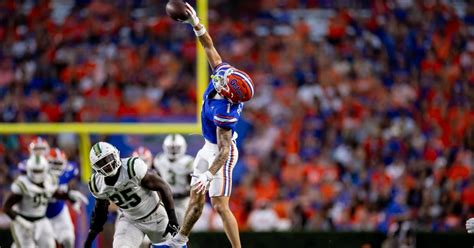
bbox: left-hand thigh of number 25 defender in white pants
[112,215,145,248]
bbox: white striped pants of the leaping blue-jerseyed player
[191,140,239,197]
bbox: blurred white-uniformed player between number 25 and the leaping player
[153,134,194,225]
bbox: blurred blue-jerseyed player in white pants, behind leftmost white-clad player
[46,148,80,248]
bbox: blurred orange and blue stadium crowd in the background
[0,0,474,237]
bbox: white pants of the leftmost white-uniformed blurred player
[10,217,56,248]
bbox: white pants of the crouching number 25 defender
[113,204,168,248]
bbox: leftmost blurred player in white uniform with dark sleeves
[4,155,88,248]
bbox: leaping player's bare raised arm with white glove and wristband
[184,3,222,69]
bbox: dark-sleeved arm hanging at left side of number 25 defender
[84,199,110,248]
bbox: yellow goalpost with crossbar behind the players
[0,0,209,182]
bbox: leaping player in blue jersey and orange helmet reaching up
[164,4,254,248]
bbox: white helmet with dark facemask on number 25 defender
[89,142,122,177]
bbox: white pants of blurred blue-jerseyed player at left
[49,205,75,248]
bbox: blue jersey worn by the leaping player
[201,63,244,144]
